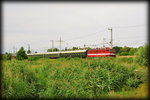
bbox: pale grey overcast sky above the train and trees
[2,2,148,53]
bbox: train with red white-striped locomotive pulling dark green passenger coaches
[27,48,116,58]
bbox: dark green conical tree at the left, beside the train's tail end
[16,47,28,60]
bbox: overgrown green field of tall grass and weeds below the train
[2,58,148,98]
